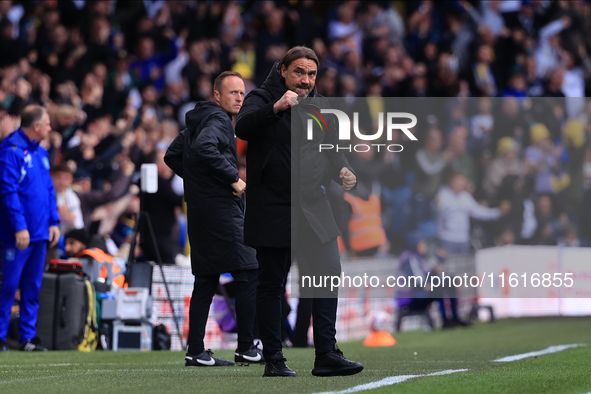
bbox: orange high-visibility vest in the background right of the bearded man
[344,193,387,252]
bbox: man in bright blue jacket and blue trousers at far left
[0,105,60,351]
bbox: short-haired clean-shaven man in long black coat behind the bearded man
[164,71,264,366]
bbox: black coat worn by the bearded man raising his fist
[236,62,353,247]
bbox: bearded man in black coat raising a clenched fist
[236,47,363,376]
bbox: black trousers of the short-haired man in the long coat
[188,269,258,355]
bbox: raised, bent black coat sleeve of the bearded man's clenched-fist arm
[236,93,283,141]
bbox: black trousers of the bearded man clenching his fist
[256,220,341,358]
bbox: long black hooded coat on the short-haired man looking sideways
[164,102,258,275]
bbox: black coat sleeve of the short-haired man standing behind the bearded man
[191,118,239,184]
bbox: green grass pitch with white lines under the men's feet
[0,317,591,394]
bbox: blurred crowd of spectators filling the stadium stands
[0,0,591,263]
